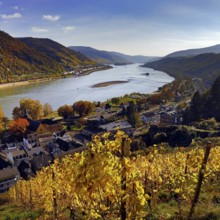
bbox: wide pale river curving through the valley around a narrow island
[0,64,174,118]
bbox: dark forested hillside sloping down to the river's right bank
[144,53,220,87]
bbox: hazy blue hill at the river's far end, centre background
[69,46,156,64]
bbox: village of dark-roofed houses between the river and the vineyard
[0,78,217,193]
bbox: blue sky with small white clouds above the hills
[0,0,220,56]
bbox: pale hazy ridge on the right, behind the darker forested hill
[165,44,220,57]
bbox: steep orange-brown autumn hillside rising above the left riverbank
[0,31,94,83]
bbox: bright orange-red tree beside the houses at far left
[9,118,29,135]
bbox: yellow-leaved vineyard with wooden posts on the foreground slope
[8,131,220,220]
